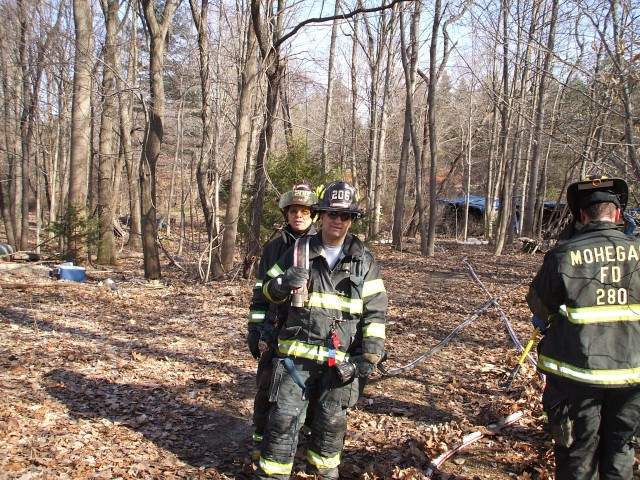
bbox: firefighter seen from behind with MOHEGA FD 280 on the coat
[527,176,640,480]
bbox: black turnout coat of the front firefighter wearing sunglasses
[263,232,387,363]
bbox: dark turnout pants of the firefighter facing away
[542,376,640,480]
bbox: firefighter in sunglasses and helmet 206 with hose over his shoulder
[258,181,387,479]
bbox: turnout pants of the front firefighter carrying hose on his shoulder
[258,358,364,480]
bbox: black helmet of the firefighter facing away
[567,175,629,219]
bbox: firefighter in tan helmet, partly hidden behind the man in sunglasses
[247,184,318,443]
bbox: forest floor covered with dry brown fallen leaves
[0,241,638,480]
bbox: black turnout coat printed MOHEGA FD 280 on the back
[527,222,640,388]
